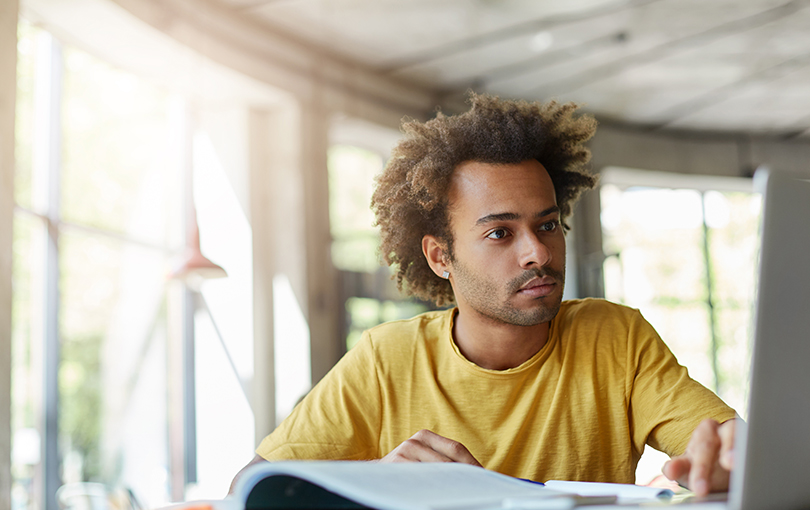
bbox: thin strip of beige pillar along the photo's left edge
[0,0,19,510]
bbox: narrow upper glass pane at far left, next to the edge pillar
[14,19,41,209]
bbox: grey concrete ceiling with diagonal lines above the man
[215,0,810,139]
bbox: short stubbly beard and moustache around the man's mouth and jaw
[452,260,565,326]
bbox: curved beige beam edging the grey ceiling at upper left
[113,0,436,118]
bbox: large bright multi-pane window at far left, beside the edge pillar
[12,21,182,509]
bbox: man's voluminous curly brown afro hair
[371,93,596,306]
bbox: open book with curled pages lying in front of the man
[224,461,592,510]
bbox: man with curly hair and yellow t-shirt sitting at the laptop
[230,95,735,495]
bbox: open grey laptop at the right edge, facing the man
[612,169,810,510]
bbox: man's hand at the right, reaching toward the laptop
[663,420,736,496]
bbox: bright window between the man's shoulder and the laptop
[601,169,761,483]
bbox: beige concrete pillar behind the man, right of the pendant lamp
[249,96,343,441]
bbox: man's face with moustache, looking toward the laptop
[448,160,565,326]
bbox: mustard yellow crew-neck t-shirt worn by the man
[256,299,734,483]
